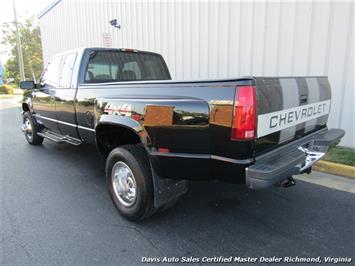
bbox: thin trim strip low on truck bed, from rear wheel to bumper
[150,151,254,164]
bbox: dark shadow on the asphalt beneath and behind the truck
[38,140,355,256]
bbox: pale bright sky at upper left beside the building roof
[0,0,54,64]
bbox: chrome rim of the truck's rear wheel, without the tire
[111,161,137,207]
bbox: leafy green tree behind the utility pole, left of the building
[1,18,43,84]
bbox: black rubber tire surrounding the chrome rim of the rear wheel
[106,144,154,221]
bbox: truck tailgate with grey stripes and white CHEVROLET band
[255,77,331,155]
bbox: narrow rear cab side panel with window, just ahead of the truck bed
[55,52,79,138]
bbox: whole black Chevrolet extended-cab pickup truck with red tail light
[21,48,344,221]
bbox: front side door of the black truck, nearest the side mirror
[32,56,62,132]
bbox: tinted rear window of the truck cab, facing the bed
[85,51,170,83]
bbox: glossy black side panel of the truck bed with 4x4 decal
[76,79,254,159]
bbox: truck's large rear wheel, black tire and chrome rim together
[106,144,154,221]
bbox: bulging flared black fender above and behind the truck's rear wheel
[96,97,210,154]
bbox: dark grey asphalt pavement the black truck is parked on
[0,108,355,265]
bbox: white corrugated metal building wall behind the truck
[39,0,355,147]
